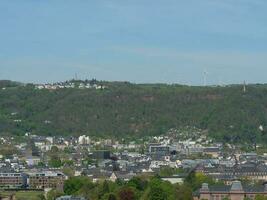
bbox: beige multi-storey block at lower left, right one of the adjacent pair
[28,171,67,191]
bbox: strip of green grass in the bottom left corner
[0,191,44,200]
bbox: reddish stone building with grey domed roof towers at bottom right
[194,181,267,200]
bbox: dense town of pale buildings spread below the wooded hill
[0,127,267,199]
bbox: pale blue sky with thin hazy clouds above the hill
[0,0,267,85]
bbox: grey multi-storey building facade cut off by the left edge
[0,172,27,189]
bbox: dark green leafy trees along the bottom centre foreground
[61,177,192,200]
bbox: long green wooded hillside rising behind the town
[0,82,267,141]
